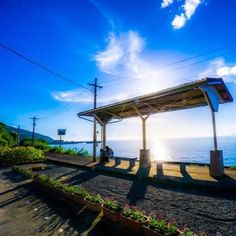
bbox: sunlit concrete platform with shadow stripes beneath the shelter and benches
[47,155,236,191]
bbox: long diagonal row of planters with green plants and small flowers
[12,166,196,236]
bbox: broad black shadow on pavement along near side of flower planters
[28,183,137,236]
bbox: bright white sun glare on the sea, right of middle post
[150,139,172,161]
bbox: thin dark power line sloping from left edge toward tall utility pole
[0,43,88,89]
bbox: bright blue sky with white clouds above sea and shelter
[0,0,236,140]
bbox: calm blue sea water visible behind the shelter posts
[60,137,236,166]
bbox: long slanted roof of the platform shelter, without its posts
[78,78,233,122]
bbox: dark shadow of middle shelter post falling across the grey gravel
[126,168,150,206]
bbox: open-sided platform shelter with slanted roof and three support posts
[78,78,233,176]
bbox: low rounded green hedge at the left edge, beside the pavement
[0,147,46,165]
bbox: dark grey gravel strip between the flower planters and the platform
[37,164,236,236]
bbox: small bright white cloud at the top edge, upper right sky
[171,0,202,29]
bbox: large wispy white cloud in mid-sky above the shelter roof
[94,31,163,79]
